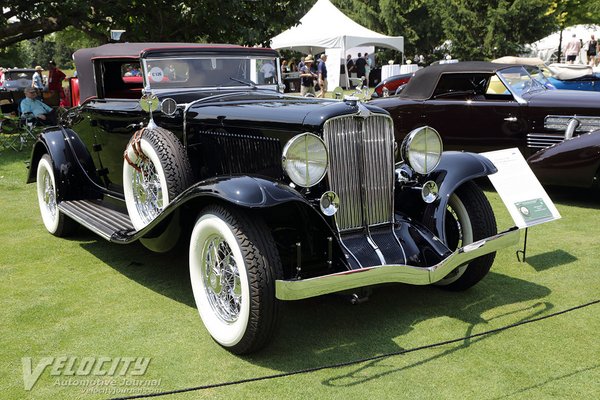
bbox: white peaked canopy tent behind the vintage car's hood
[271,0,404,88]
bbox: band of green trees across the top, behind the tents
[0,0,600,67]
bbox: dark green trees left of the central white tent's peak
[0,0,313,47]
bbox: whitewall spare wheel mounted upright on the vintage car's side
[123,127,193,230]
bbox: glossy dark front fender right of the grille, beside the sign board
[429,151,497,242]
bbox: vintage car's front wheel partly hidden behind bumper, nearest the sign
[423,181,498,291]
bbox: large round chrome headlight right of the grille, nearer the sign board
[400,126,443,174]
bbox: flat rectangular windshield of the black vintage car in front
[143,56,279,89]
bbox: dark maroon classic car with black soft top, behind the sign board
[370,62,600,187]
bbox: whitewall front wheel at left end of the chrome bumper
[189,206,283,354]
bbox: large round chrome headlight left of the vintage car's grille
[281,133,328,187]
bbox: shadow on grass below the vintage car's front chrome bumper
[247,272,553,372]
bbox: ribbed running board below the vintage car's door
[58,200,135,241]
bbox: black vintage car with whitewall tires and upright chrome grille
[28,43,519,353]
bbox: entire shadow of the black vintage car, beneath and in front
[74,235,553,380]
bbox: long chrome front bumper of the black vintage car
[275,227,520,300]
